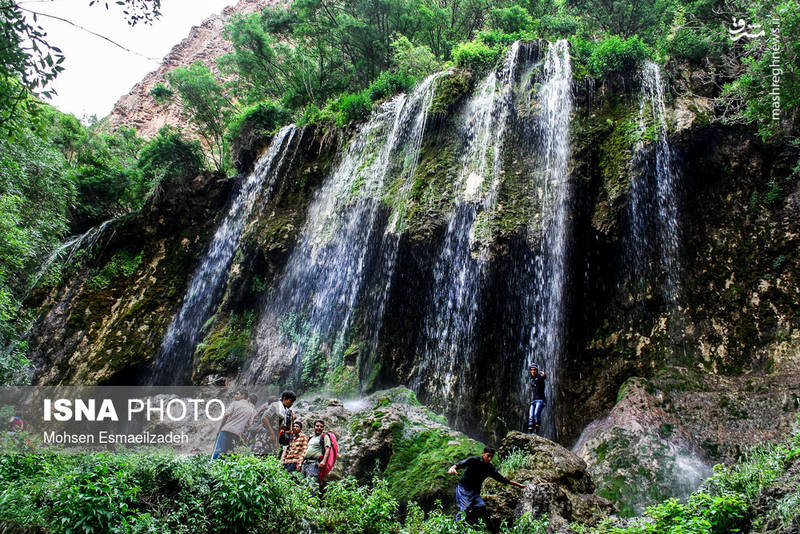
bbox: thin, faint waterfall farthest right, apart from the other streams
[629,61,680,304]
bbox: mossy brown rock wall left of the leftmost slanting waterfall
[28,174,234,384]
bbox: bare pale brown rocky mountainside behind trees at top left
[108,0,268,139]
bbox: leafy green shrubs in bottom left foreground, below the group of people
[0,452,546,534]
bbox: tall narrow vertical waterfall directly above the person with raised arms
[521,40,572,439]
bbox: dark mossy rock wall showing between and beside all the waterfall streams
[23,53,800,460]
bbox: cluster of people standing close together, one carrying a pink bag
[211,390,338,482]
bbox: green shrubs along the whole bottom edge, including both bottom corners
[0,431,800,534]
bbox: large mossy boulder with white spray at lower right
[575,368,800,515]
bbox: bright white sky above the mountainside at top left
[19,0,236,118]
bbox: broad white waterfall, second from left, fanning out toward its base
[240,73,442,387]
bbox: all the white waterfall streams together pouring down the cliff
[150,41,680,452]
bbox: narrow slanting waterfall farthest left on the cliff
[148,125,297,385]
